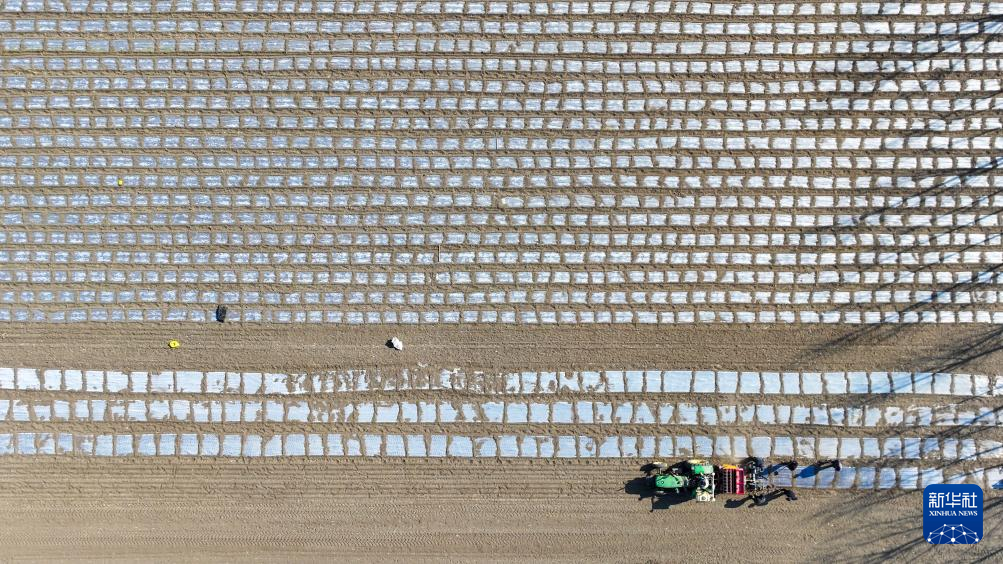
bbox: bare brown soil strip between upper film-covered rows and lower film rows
[0,323,1003,373]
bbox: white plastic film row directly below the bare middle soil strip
[0,367,1003,397]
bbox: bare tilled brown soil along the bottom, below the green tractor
[0,460,1003,562]
